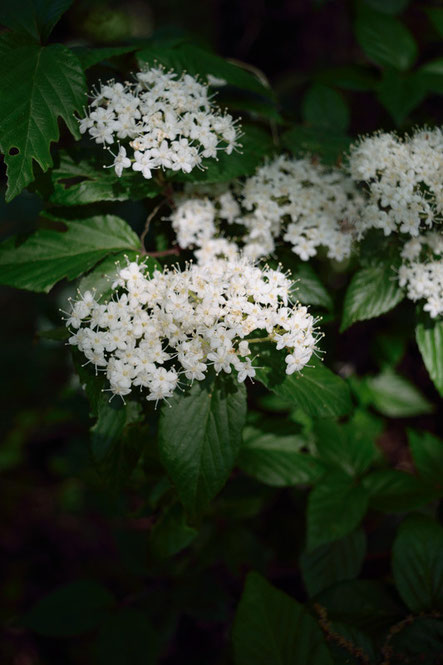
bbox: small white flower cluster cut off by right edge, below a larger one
[399,231,443,318]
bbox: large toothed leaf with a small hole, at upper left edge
[0,44,86,201]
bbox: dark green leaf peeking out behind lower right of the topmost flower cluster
[170,125,273,185]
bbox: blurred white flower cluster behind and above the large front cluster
[171,156,363,261]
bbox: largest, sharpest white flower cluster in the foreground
[67,258,316,401]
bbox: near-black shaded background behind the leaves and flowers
[0,0,441,665]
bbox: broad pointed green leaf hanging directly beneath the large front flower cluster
[159,376,246,515]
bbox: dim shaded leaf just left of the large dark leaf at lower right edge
[300,529,366,597]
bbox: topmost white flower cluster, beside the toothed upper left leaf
[80,68,239,178]
